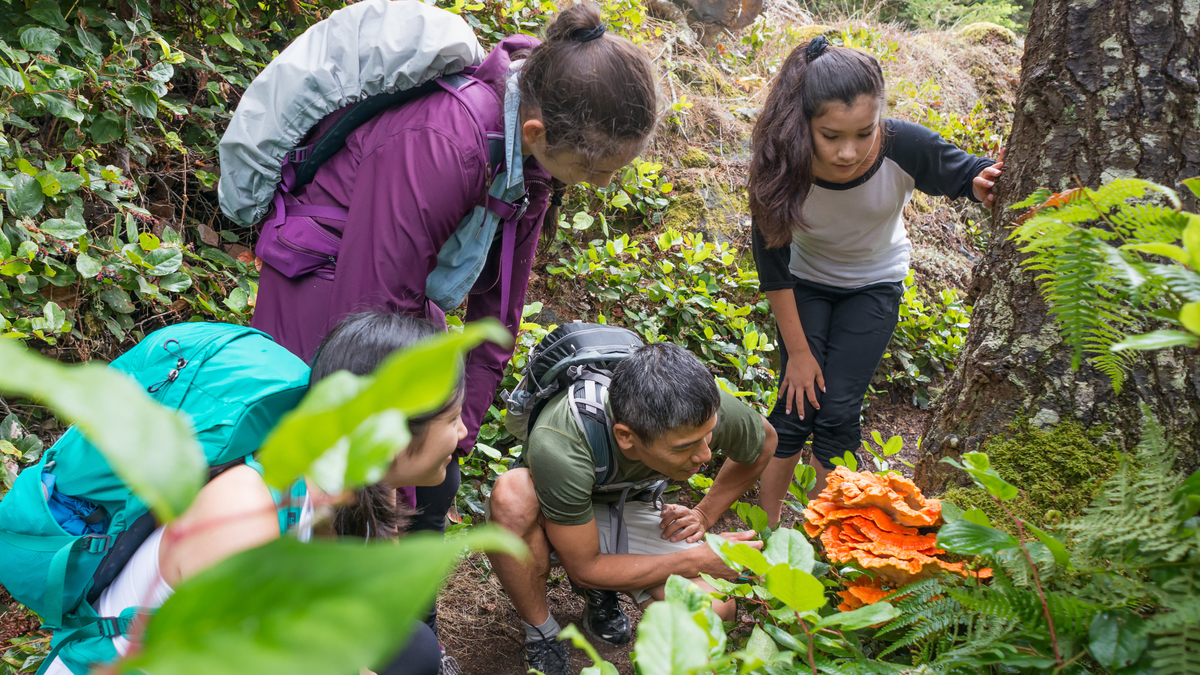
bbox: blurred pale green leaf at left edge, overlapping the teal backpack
[0,340,208,522]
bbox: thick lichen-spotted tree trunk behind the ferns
[917,0,1200,491]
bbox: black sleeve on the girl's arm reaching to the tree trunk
[887,119,996,202]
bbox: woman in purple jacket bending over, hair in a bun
[252,4,656,540]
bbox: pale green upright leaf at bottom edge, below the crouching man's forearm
[632,601,708,675]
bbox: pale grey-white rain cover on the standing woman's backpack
[217,0,484,226]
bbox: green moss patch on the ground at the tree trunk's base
[940,423,1120,533]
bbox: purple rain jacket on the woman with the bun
[251,35,551,456]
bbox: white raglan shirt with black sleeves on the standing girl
[754,119,995,292]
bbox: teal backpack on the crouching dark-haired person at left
[0,323,308,675]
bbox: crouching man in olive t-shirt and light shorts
[488,342,776,675]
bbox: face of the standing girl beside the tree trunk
[811,94,880,183]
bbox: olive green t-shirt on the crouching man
[521,390,766,525]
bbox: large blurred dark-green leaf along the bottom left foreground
[126,527,524,675]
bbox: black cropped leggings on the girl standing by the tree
[767,277,904,470]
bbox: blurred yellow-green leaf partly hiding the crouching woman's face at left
[259,321,512,488]
